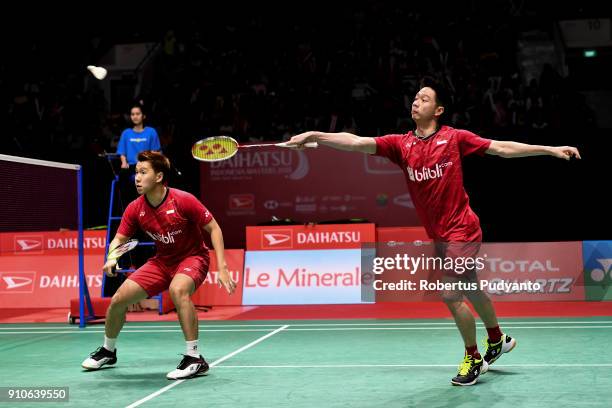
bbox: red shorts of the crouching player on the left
[128,254,210,296]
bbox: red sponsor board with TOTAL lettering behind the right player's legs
[376,241,585,302]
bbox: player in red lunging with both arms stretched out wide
[289,78,580,385]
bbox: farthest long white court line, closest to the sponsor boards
[0,320,612,331]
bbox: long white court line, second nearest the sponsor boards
[0,326,612,335]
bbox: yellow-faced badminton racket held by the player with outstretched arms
[191,136,319,162]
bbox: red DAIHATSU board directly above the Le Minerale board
[247,224,376,251]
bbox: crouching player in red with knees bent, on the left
[82,150,236,380]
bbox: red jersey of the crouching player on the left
[117,188,213,264]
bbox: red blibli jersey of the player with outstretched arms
[375,126,491,242]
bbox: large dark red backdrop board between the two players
[200,147,420,248]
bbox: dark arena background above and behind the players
[0,0,612,241]
